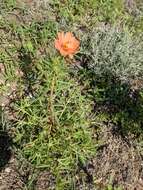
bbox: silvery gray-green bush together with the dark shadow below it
[77,26,143,135]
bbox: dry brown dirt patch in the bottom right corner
[83,126,143,190]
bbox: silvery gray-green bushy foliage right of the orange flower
[83,28,143,82]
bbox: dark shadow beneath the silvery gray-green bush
[79,68,143,136]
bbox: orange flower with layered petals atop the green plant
[55,32,80,58]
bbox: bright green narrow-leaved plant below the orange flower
[14,58,95,189]
